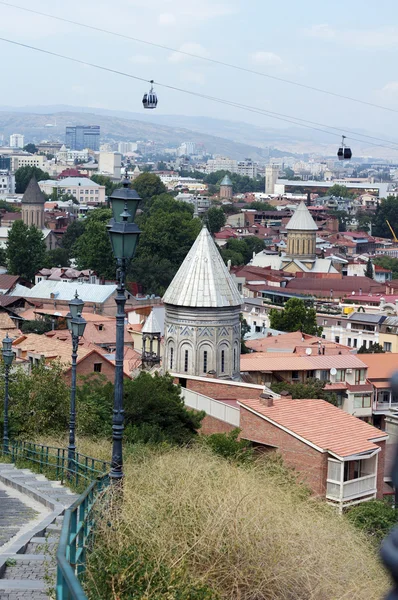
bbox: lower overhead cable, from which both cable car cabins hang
[0,37,398,150]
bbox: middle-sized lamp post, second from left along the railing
[66,290,86,476]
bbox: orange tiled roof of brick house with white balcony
[239,398,388,457]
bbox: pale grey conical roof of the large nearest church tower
[163,227,242,308]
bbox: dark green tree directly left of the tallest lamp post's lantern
[72,208,116,279]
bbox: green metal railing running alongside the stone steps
[2,441,110,600]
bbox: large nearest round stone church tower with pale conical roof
[163,227,242,379]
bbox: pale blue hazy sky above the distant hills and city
[0,0,398,141]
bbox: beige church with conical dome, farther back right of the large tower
[250,202,338,273]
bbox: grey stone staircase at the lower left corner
[0,463,78,600]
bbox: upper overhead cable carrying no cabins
[0,0,398,113]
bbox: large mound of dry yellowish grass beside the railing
[79,443,389,600]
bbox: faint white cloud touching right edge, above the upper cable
[304,23,398,49]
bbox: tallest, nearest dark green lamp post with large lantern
[108,175,141,483]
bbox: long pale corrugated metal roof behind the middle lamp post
[11,279,117,303]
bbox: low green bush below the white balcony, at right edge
[346,500,397,544]
